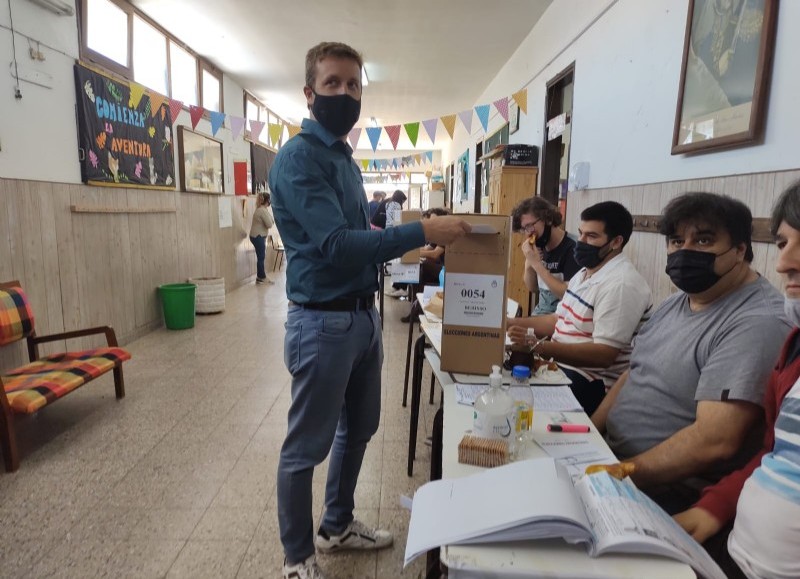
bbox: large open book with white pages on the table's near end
[405,458,725,579]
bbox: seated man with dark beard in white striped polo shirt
[508,201,652,414]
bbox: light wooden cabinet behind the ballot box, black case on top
[488,165,539,316]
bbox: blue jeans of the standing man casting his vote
[278,305,383,564]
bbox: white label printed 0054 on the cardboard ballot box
[444,272,505,328]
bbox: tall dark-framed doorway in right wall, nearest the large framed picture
[540,62,575,214]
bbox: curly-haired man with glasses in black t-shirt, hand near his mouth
[511,197,580,316]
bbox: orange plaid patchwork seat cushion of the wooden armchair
[1,348,131,414]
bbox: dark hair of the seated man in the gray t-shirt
[658,191,753,262]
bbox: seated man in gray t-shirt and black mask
[592,193,790,513]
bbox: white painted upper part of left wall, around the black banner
[0,0,247,194]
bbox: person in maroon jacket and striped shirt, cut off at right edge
[675,182,800,579]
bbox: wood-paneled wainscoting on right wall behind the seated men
[566,170,800,304]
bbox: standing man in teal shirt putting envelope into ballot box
[269,42,470,579]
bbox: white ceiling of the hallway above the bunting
[132,0,552,150]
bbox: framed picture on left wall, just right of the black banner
[178,126,225,194]
